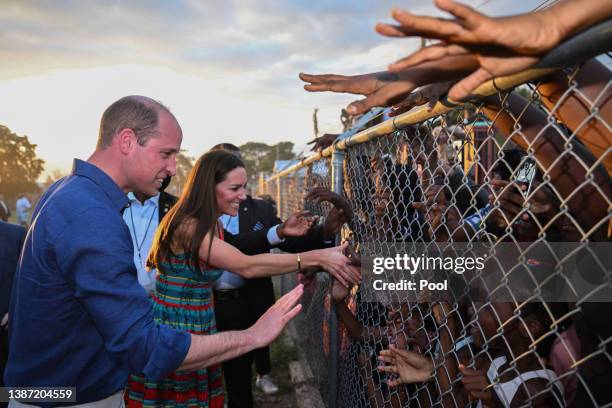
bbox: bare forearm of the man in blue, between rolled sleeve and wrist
[178,329,259,371]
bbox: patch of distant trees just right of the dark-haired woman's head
[239,142,295,177]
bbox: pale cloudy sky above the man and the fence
[0,0,541,179]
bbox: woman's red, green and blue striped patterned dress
[126,241,224,408]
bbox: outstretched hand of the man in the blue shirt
[248,285,304,348]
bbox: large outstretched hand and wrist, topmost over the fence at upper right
[376,0,612,100]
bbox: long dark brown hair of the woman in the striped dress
[148,150,244,270]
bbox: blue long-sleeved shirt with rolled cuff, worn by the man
[4,160,191,403]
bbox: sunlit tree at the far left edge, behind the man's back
[0,125,45,207]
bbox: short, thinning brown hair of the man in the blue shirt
[98,95,174,149]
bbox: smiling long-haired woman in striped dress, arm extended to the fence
[126,151,359,408]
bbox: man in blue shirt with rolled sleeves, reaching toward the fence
[4,96,301,406]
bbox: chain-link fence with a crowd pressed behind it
[256,23,612,407]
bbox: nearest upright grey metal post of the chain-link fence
[327,150,345,408]
